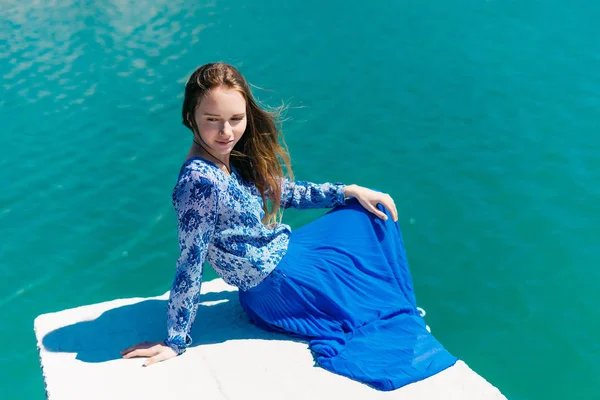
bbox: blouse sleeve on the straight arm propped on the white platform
[165,172,217,354]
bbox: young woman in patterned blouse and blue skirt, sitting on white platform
[122,63,456,390]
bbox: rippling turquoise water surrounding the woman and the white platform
[0,0,600,399]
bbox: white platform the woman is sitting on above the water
[34,279,506,400]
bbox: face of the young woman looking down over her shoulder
[194,87,248,155]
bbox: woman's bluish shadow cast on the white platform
[42,291,304,363]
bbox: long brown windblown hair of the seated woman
[181,62,293,224]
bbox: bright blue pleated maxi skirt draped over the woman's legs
[239,200,457,390]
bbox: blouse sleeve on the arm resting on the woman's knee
[281,178,345,209]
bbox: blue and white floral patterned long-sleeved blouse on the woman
[165,157,344,354]
